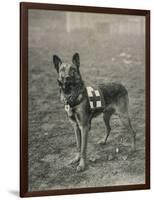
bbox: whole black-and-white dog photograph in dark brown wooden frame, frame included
[20,2,150,197]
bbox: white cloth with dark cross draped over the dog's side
[86,86,105,110]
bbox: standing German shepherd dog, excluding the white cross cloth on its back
[53,53,136,171]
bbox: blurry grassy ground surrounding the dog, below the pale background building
[29,11,145,191]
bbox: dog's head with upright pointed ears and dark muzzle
[53,53,81,93]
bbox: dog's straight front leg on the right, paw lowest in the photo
[77,126,89,172]
